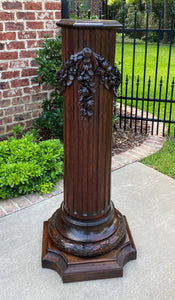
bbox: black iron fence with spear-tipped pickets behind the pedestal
[62,4,175,136]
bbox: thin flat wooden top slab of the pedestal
[56,19,122,29]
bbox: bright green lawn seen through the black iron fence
[115,42,175,132]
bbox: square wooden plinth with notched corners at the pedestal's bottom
[42,218,136,283]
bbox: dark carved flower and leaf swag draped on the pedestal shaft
[56,47,120,120]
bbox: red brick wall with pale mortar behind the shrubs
[0,0,61,135]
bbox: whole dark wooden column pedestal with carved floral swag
[42,20,136,282]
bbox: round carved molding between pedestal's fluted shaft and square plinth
[48,203,126,257]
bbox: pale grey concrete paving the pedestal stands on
[0,162,175,300]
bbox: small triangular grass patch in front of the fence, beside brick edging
[141,138,175,179]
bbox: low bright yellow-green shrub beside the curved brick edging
[0,133,63,199]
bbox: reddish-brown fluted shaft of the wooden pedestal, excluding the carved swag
[60,21,118,220]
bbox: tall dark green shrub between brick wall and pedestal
[34,36,63,140]
